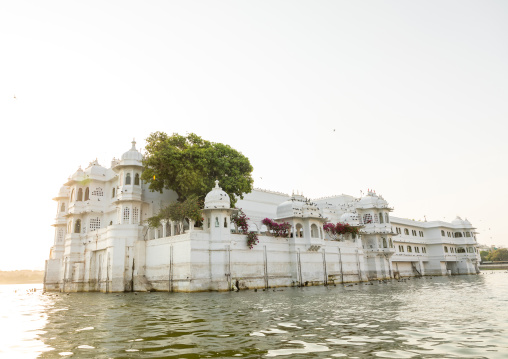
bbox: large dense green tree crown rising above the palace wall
[141,132,254,207]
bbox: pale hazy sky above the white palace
[0,0,508,270]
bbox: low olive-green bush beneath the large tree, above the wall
[146,196,203,232]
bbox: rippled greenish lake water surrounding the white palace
[0,271,508,358]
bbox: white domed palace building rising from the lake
[44,142,479,292]
